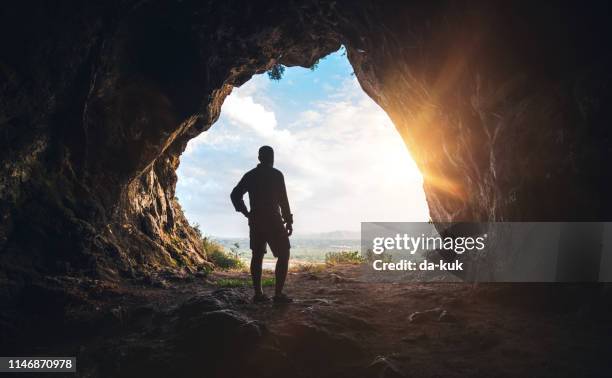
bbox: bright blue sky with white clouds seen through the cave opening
[176,49,429,237]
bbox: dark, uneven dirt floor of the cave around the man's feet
[0,265,612,377]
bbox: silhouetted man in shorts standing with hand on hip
[231,146,293,303]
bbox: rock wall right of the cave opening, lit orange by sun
[342,2,611,221]
